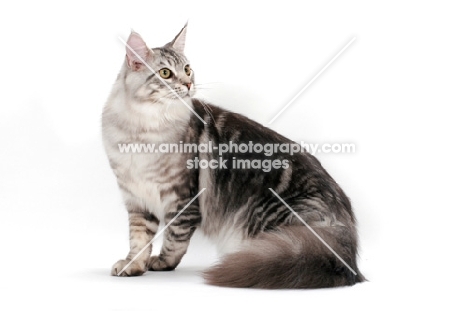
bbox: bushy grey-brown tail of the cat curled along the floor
[204,227,365,289]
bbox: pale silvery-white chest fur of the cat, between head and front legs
[103,96,190,220]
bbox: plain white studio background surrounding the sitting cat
[0,0,468,310]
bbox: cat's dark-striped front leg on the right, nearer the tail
[148,206,201,271]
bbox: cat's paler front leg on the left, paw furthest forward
[111,211,159,276]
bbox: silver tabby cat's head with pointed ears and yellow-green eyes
[121,25,195,104]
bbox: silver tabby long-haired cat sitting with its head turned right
[102,25,365,289]
